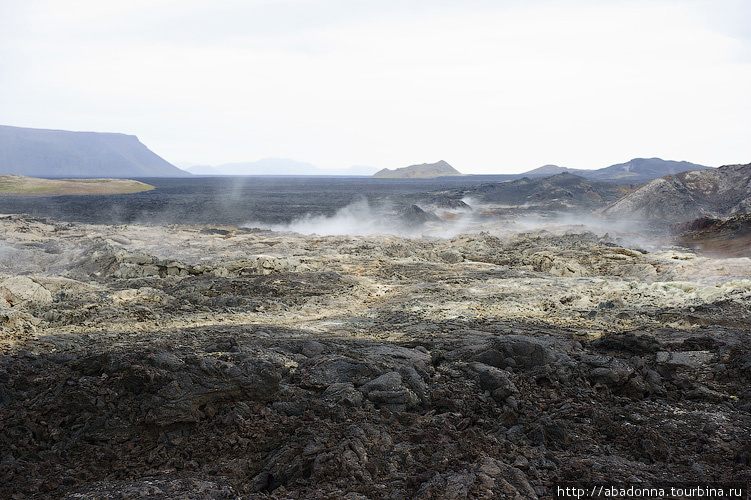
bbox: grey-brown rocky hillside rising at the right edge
[601,163,751,221]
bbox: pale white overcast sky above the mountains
[0,0,751,173]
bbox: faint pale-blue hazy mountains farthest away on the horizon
[185,158,377,176]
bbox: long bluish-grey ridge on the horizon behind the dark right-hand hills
[520,158,711,184]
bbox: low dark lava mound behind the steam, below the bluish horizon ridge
[423,172,628,210]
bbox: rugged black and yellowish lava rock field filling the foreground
[0,216,751,500]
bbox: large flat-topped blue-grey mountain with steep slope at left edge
[0,125,190,177]
